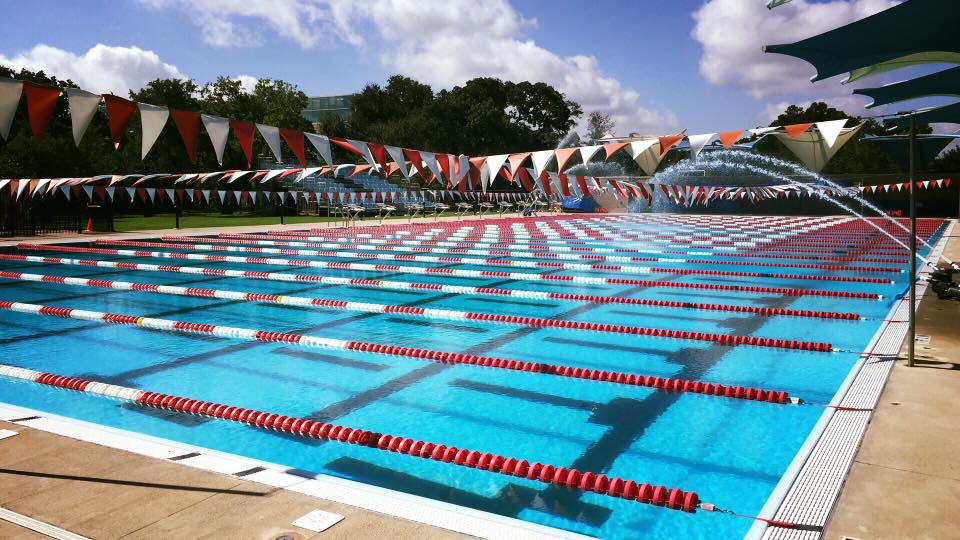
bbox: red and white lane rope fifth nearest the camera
[16,243,883,300]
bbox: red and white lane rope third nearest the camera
[0,271,833,352]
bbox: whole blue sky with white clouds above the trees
[0,0,944,133]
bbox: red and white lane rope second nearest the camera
[0,300,800,405]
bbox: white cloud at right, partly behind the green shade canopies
[691,0,898,98]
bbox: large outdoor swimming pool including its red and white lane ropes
[0,215,942,538]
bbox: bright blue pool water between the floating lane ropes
[0,216,944,538]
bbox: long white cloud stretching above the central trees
[141,0,680,133]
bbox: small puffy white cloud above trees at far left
[0,43,186,96]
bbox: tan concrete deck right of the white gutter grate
[824,229,960,539]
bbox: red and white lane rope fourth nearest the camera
[0,253,868,321]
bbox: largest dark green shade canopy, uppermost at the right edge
[763,0,960,81]
